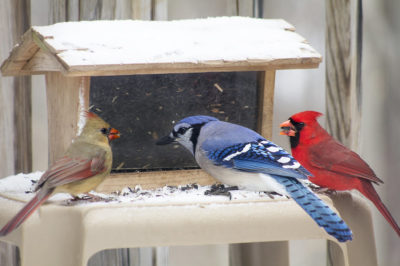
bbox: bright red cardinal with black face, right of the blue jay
[280,111,400,236]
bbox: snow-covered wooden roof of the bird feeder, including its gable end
[1,17,321,76]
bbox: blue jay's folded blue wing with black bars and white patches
[207,139,311,179]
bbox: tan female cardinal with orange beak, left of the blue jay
[0,112,119,236]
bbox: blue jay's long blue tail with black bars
[274,176,353,242]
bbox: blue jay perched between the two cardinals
[157,116,352,242]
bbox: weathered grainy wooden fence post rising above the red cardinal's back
[326,0,362,150]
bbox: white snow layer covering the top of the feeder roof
[33,17,321,66]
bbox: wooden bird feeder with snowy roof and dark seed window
[1,17,321,192]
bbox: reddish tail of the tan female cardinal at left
[0,190,52,236]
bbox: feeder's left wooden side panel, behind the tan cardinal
[46,72,90,165]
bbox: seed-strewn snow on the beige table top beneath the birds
[0,172,286,205]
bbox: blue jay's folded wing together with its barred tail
[207,139,352,242]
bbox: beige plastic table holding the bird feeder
[0,188,376,266]
